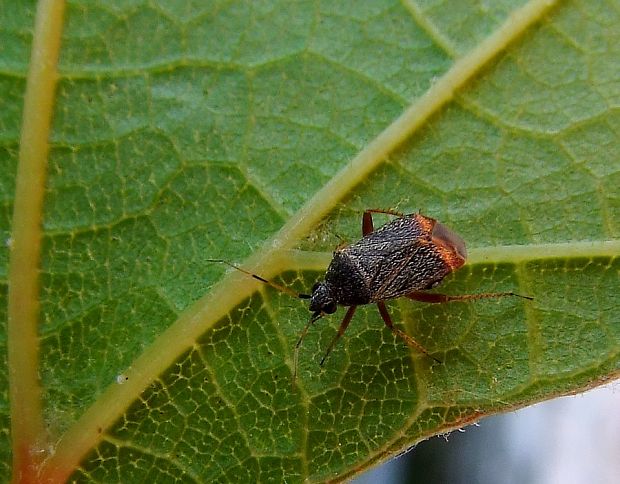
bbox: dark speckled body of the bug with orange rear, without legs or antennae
[310,212,467,313]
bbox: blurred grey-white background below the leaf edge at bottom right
[353,381,620,484]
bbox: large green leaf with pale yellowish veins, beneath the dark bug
[0,0,620,482]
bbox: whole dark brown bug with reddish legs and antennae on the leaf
[211,209,533,380]
